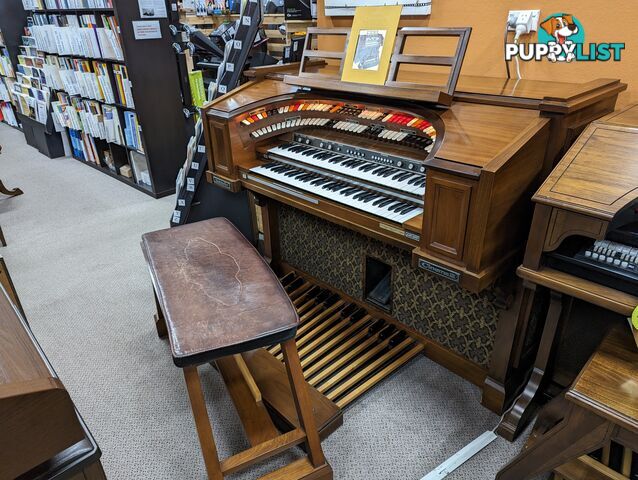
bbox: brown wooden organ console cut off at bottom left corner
[0,283,106,480]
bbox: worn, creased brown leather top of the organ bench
[142,218,299,367]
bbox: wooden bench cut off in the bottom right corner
[496,329,638,480]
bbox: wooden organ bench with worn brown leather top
[142,218,332,480]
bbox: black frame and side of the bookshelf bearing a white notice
[19,0,188,198]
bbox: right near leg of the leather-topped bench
[282,339,326,468]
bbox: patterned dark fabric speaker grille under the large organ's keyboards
[279,205,502,367]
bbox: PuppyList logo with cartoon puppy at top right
[505,13,625,62]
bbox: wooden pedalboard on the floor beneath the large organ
[268,272,424,408]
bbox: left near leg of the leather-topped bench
[184,367,224,480]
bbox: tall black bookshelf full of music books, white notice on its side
[18,0,187,198]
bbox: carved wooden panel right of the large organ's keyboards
[422,172,476,262]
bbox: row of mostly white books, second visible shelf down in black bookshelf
[29,13,124,61]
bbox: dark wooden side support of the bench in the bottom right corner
[496,404,614,480]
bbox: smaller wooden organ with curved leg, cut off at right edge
[497,105,638,439]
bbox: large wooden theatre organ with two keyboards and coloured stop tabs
[204,28,625,416]
